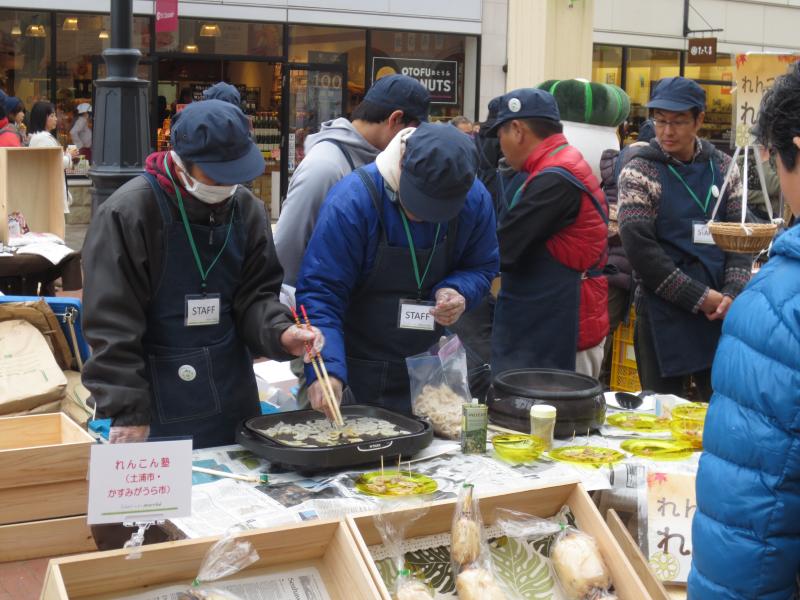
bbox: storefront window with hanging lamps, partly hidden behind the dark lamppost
[56,13,150,145]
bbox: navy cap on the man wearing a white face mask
[171,100,265,185]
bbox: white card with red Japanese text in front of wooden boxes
[87,440,192,525]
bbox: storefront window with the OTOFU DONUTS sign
[370,31,476,120]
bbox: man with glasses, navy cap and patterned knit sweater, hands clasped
[619,77,751,401]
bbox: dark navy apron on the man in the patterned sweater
[642,160,727,377]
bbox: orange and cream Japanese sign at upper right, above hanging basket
[734,53,800,146]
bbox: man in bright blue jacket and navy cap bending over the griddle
[297,123,498,413]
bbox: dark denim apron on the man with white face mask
[144,173,260,448]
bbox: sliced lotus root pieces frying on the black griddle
[257,417,410,448]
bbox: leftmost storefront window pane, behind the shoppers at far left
[0,10,52,111]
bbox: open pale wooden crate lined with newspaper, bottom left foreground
[41,520,379,600]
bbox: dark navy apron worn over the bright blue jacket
[343,167,458,414]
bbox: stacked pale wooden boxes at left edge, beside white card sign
[0,413,95,562]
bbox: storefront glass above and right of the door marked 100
[289,25,367,113]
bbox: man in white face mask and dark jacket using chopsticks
[83,100,321,448]
